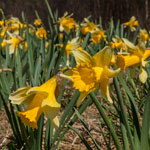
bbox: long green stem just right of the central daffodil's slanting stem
[114,77,135,150]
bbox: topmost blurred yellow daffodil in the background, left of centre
[58,12,75,33]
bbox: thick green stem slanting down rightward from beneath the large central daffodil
[90,93,122,150]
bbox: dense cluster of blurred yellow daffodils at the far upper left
[0,17,47,54]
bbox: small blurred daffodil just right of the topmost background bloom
[81,18,98,35]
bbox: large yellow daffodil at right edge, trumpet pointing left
[116,39,150,83]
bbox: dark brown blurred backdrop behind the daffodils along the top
[0,0,150,28]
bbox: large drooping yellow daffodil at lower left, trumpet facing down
[9,77,60,129]
